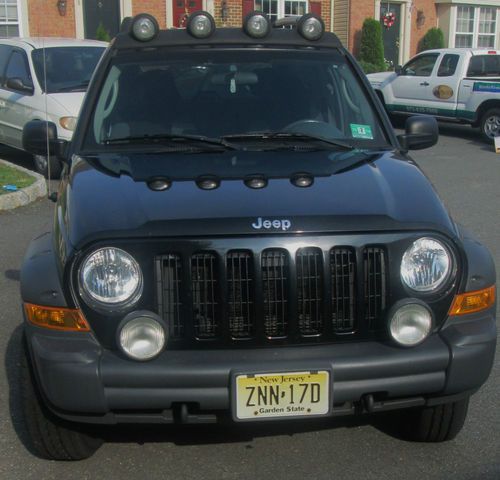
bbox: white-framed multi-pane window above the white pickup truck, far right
[455,5,497,48]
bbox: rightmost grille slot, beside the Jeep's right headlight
[363,247,387,328]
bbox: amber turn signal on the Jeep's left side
[24,303,90,332]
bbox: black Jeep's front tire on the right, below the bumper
[400,397,469,442]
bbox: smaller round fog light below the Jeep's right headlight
[389,303,432,347]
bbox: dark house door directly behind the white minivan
[83,0,120,40]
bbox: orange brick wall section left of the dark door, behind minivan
[28,0,76,37]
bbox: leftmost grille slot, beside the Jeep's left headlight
[156,255,184,338]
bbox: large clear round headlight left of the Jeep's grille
[80,247,143,308]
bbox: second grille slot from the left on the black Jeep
[191,253,220,339]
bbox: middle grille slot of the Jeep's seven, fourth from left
[261,249,289,338]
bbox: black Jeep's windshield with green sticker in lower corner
[85,49,387,151]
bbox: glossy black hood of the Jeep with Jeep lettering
[64,151,454,248]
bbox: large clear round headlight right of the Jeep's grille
[401,237,452,292]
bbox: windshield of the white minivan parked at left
[31,47,104,93]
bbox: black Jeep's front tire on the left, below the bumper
[20,339,103,460]
